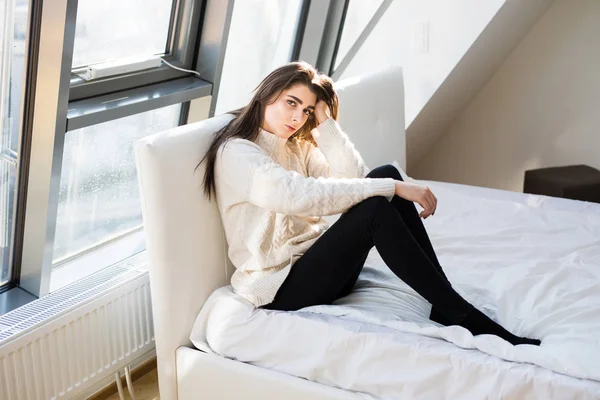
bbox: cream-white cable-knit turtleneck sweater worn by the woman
[215,118,395,307]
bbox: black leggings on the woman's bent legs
[263,165,473,324]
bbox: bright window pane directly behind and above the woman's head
[216,0,302,114]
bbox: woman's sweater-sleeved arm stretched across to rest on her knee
[216,139,396,216]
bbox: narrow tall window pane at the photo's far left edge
[0,0,29,285]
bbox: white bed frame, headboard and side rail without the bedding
[135,67,406,400]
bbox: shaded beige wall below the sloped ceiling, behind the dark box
[410,0,600,191]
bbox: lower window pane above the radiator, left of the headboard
[54,105,181,262]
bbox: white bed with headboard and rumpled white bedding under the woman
[136,68,600,399]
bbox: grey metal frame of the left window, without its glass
[10,0,235,300]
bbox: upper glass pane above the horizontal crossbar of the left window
[73,0,174,68]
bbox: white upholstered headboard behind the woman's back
[135,67,406,399]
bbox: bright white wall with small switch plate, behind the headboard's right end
[337,0,504,126]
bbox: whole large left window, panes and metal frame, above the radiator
[0,0,230,311]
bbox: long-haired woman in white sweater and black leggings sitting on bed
[202,62,540,345]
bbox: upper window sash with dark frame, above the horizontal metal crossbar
[67,0,202,101]
